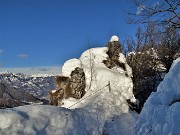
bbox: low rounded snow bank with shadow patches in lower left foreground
[0,105,88,135]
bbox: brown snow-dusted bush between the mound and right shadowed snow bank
[127,46,166,108]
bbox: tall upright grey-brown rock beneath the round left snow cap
[70,67,86,99]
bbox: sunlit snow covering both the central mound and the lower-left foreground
[0,44,137,135]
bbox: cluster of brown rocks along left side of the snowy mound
[48,67,86,106]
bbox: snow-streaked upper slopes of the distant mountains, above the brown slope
[0,72,55,98]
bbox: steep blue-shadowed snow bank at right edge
[136,58,180,135]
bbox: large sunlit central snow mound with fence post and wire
[62,47,136,134]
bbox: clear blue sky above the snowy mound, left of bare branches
[0,0,137,68]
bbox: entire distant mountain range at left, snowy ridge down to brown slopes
[0,72,55,107]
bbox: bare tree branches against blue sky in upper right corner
[128,0,180,29]
